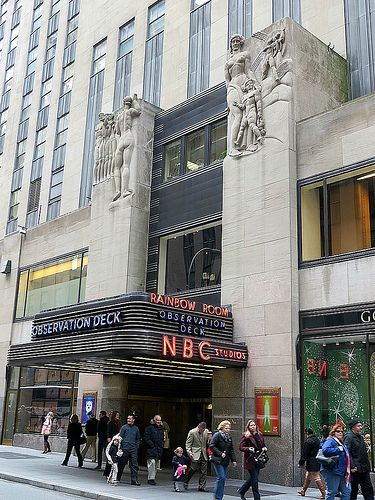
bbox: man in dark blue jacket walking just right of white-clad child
[117,414,141,486]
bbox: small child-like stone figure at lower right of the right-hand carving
[233,79,266,151]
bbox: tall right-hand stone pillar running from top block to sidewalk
[222,19,346,485]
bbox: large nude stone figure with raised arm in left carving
[112,94,141,201]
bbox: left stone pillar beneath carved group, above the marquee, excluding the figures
[86,101,157,300]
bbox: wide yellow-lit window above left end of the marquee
[16,252,88,318]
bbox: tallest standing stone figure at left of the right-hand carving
[224,35,257,155]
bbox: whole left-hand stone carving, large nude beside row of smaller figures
[94,94,141,201]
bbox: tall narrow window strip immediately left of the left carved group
[79,40,107,207]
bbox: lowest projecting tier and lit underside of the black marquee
[8,332,247,379]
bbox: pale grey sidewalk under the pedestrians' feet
[0,446,320,500]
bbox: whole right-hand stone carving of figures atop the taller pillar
[225,23,292,156]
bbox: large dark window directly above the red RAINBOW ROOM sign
[159,225,221,294]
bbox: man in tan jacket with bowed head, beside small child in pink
[185,422,212,491]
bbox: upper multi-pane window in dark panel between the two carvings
[164,120,227,180]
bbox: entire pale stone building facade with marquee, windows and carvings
[0,0,375,484]
